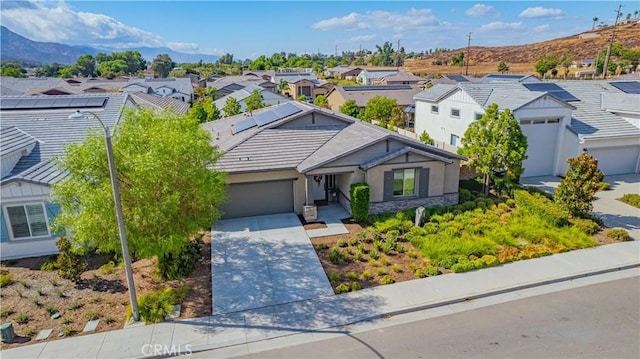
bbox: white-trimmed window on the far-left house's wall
[6,203,49,239]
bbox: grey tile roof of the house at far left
[0,93,129,185]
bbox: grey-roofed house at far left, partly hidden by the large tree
[0,93,134,260]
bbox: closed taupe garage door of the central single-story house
[222,180,293,218]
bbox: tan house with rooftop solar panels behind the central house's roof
[327,85,422,112]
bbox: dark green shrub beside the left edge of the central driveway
[158,234,203,280]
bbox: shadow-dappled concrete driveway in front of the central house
[211,213,333,315]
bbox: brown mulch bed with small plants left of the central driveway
[0,232,212,349]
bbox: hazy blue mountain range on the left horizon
[0,26,218,65]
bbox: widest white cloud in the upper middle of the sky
[311,9,439,32]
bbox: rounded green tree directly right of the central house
[459,103,527,194]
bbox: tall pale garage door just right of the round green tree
[520,120,560,177]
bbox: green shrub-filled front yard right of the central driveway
[312,190,626,293]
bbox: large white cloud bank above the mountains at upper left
[0,1,197,51]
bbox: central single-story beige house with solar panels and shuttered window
[202,101,464,218]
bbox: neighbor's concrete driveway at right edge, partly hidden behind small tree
[520,173,640,240]
